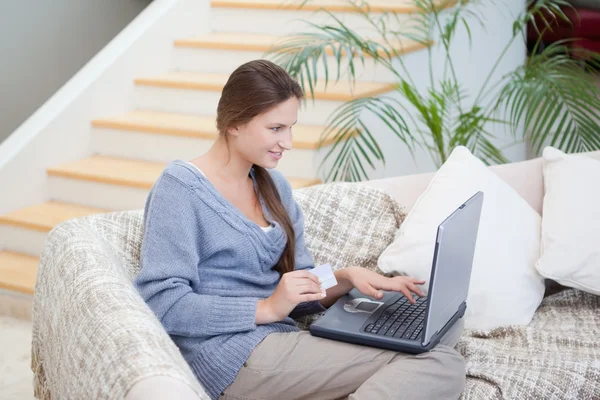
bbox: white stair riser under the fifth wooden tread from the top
[48,176,149,211]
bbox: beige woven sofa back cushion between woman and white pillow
[294,183,405,272]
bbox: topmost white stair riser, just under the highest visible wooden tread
[210,8,411,37]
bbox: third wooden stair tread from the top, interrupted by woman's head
[135,72,396,101]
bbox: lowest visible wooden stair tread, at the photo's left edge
[0,250,40,294]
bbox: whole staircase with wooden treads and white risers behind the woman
[0,0,432,301]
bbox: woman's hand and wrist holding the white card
[256,270,325,324]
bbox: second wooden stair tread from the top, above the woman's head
[175,32,426,56]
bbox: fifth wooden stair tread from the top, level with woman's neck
[48,156,321,190]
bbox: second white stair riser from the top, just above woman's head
[172,47,396,83]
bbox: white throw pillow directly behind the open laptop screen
[378,146,545,330]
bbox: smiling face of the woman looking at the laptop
[229,97,300,168]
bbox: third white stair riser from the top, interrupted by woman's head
[134,86,344,125]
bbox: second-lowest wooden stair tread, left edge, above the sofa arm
[0,201,109,232]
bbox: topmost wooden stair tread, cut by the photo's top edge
[211,0,456,14]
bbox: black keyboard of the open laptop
[365,296,427,340]
